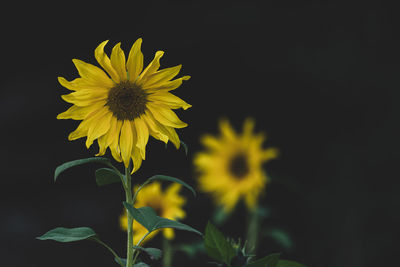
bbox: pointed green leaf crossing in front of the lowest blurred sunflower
[124,202,202,235]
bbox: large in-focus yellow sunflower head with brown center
[57,38,191,173]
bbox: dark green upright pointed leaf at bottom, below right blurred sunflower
[204,222,236,266]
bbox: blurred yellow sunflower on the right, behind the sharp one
[194,119,278,212]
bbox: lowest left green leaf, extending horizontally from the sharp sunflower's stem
[37,227,97,242]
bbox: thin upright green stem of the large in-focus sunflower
[124,165,134,267]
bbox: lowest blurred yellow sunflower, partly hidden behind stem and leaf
[120,182,186,244]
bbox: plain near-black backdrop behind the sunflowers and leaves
[0,1,400,267]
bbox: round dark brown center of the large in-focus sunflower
[106,81,147,121]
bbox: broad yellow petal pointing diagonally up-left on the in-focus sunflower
[72,59,114,88]
